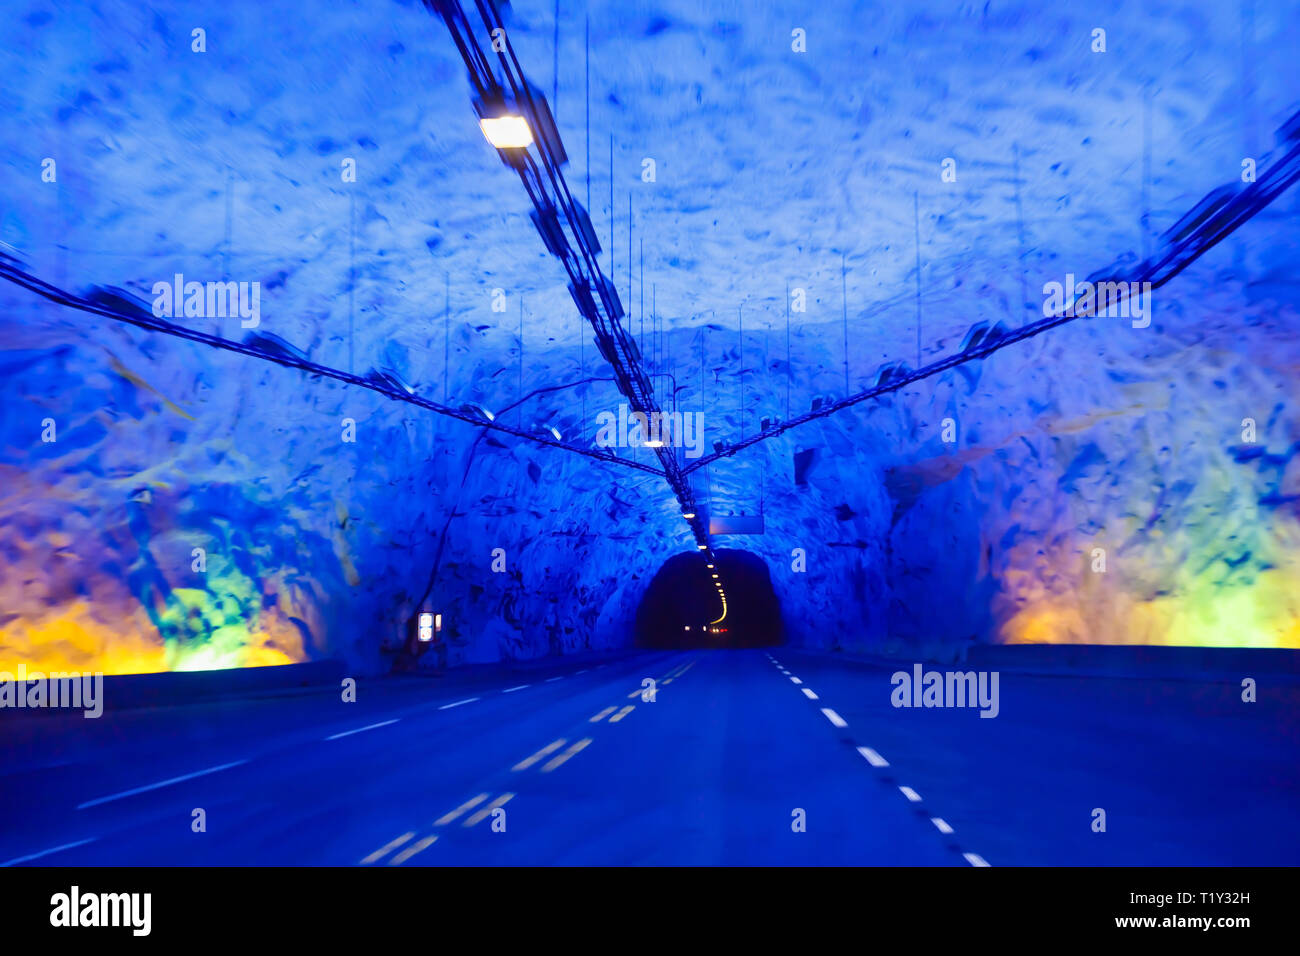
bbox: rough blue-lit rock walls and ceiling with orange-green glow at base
[0,3,1300,670]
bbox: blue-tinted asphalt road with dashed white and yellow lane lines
[0,648,1300,866]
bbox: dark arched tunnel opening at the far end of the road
[636,549,785,648]
